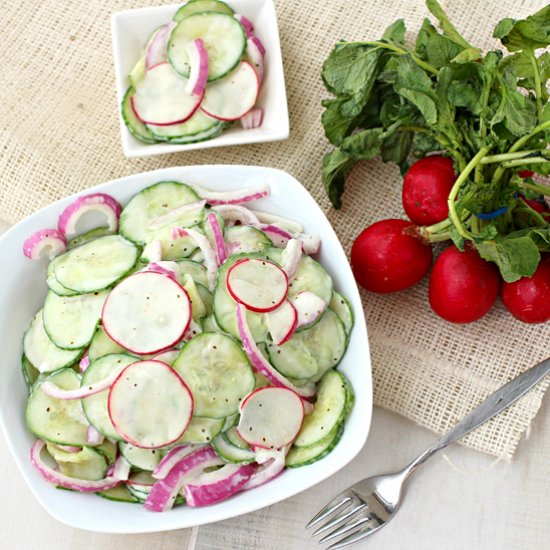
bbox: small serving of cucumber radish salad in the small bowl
[121,0,266,144]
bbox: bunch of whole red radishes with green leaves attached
[322,0,550,323]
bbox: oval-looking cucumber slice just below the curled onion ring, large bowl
[53,235,139,293]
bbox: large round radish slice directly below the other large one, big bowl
[108,360,193,449]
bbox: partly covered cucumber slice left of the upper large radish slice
[42,290,109,352]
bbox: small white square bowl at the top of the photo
[111,0,289,157]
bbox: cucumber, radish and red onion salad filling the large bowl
[22,179,354,512]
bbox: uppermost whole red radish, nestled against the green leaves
[402,155,456,225]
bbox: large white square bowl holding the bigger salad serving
[0,165,372,533]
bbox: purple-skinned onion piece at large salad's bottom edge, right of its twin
[183,464,254,506]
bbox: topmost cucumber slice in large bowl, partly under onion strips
[119,181,202,245]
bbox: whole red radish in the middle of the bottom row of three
[429,245,500,323]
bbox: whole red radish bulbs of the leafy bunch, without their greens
[351,155,550,323]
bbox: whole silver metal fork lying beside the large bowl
[306,358,550,550]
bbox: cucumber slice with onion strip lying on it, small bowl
[168,12,246,82]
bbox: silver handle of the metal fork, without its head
[402,358,550,477]
